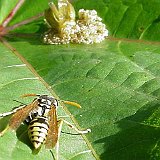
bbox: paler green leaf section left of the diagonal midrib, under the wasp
[0,41,95,160]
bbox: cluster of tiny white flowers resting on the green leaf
[43,9,108,44]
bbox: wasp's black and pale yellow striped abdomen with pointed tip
[28,117,49,149]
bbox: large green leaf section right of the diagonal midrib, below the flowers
[9,37,160,159]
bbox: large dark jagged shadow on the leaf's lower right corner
[95,104,160,160]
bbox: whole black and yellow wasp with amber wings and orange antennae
[0,94,91,159]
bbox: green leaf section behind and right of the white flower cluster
[74,0,160,41]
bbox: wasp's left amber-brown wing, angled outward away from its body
[9,100,38,130]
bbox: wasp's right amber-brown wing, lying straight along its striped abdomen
[45,106,58,149]
